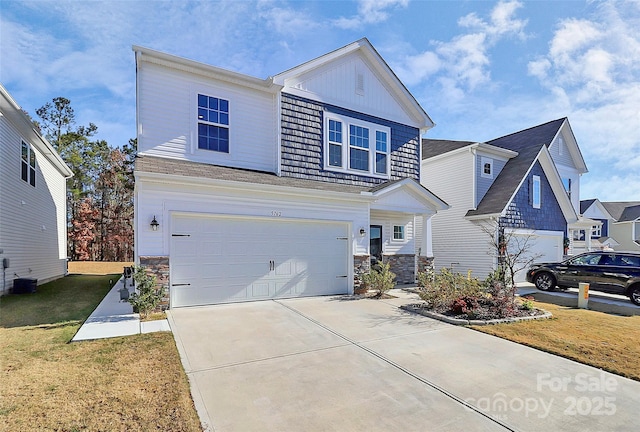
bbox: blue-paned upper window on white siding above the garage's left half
[198,94,229,153]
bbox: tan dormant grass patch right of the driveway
[471,302,640,381]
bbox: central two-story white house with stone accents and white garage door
[133,39,447,307]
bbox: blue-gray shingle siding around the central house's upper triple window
[281,93,420,186]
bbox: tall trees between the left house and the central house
[34,97,137,261]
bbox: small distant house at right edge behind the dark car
[580,198,640,251]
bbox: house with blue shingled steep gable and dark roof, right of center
[421,118,597,280]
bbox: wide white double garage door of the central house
[170,215,349,307]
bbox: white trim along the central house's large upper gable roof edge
[271,38,435,132]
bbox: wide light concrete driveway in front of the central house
[169,297,640,432]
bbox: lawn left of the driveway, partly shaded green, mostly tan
[0,275,201,431]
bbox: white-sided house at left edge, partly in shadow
[0,85,73,294]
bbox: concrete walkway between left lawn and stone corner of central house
[71,278,171,342]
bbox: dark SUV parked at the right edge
[527,251,640,306]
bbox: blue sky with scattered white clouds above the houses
[0,0,640,201]
